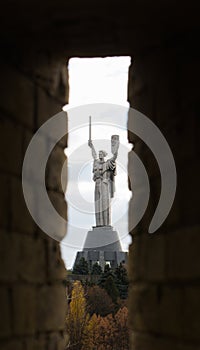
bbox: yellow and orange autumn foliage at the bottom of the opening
[66,281,129,350]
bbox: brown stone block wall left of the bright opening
[0,57,68,350]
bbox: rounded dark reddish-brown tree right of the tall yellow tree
[86,286,114,316]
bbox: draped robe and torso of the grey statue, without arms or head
[93,157,116,226]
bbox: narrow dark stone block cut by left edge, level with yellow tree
[0,287,12,338]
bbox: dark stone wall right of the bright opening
[129,45,200,350]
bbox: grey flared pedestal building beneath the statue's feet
[75,226,128,270]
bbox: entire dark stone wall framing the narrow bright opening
[0,0,200,350]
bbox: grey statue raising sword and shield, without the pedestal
[88,117,119,227]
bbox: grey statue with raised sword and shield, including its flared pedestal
[74,117,128,270]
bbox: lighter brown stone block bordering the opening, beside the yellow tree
[37,285,67,331]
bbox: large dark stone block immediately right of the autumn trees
[129,285,183,337]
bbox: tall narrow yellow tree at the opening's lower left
[66,281,89,350]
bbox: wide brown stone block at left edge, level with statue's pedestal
[0,231,46,283]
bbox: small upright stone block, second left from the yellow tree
[12,284,38,335]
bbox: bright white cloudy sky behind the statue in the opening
[61,57,133,269]
